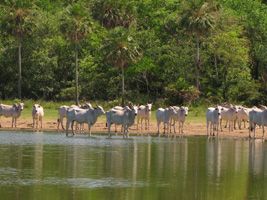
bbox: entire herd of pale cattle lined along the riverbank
[0,103,267,138]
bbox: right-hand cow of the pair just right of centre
[170,106,188,134]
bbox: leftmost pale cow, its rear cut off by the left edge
[0,103,24,128]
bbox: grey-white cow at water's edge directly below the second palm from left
[66,106,105,136]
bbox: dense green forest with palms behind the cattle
[0,0,267,105]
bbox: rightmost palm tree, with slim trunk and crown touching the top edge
[181,1,219,90]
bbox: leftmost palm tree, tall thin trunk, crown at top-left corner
[1,0,34,99]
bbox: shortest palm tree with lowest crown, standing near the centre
[104,27,141,106]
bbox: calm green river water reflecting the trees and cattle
[0,131,267,200]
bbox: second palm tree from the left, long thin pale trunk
[60,3,91,105]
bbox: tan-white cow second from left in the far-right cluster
[219,106,238,132]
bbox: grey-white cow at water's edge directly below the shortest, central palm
[106,105,136,138]
